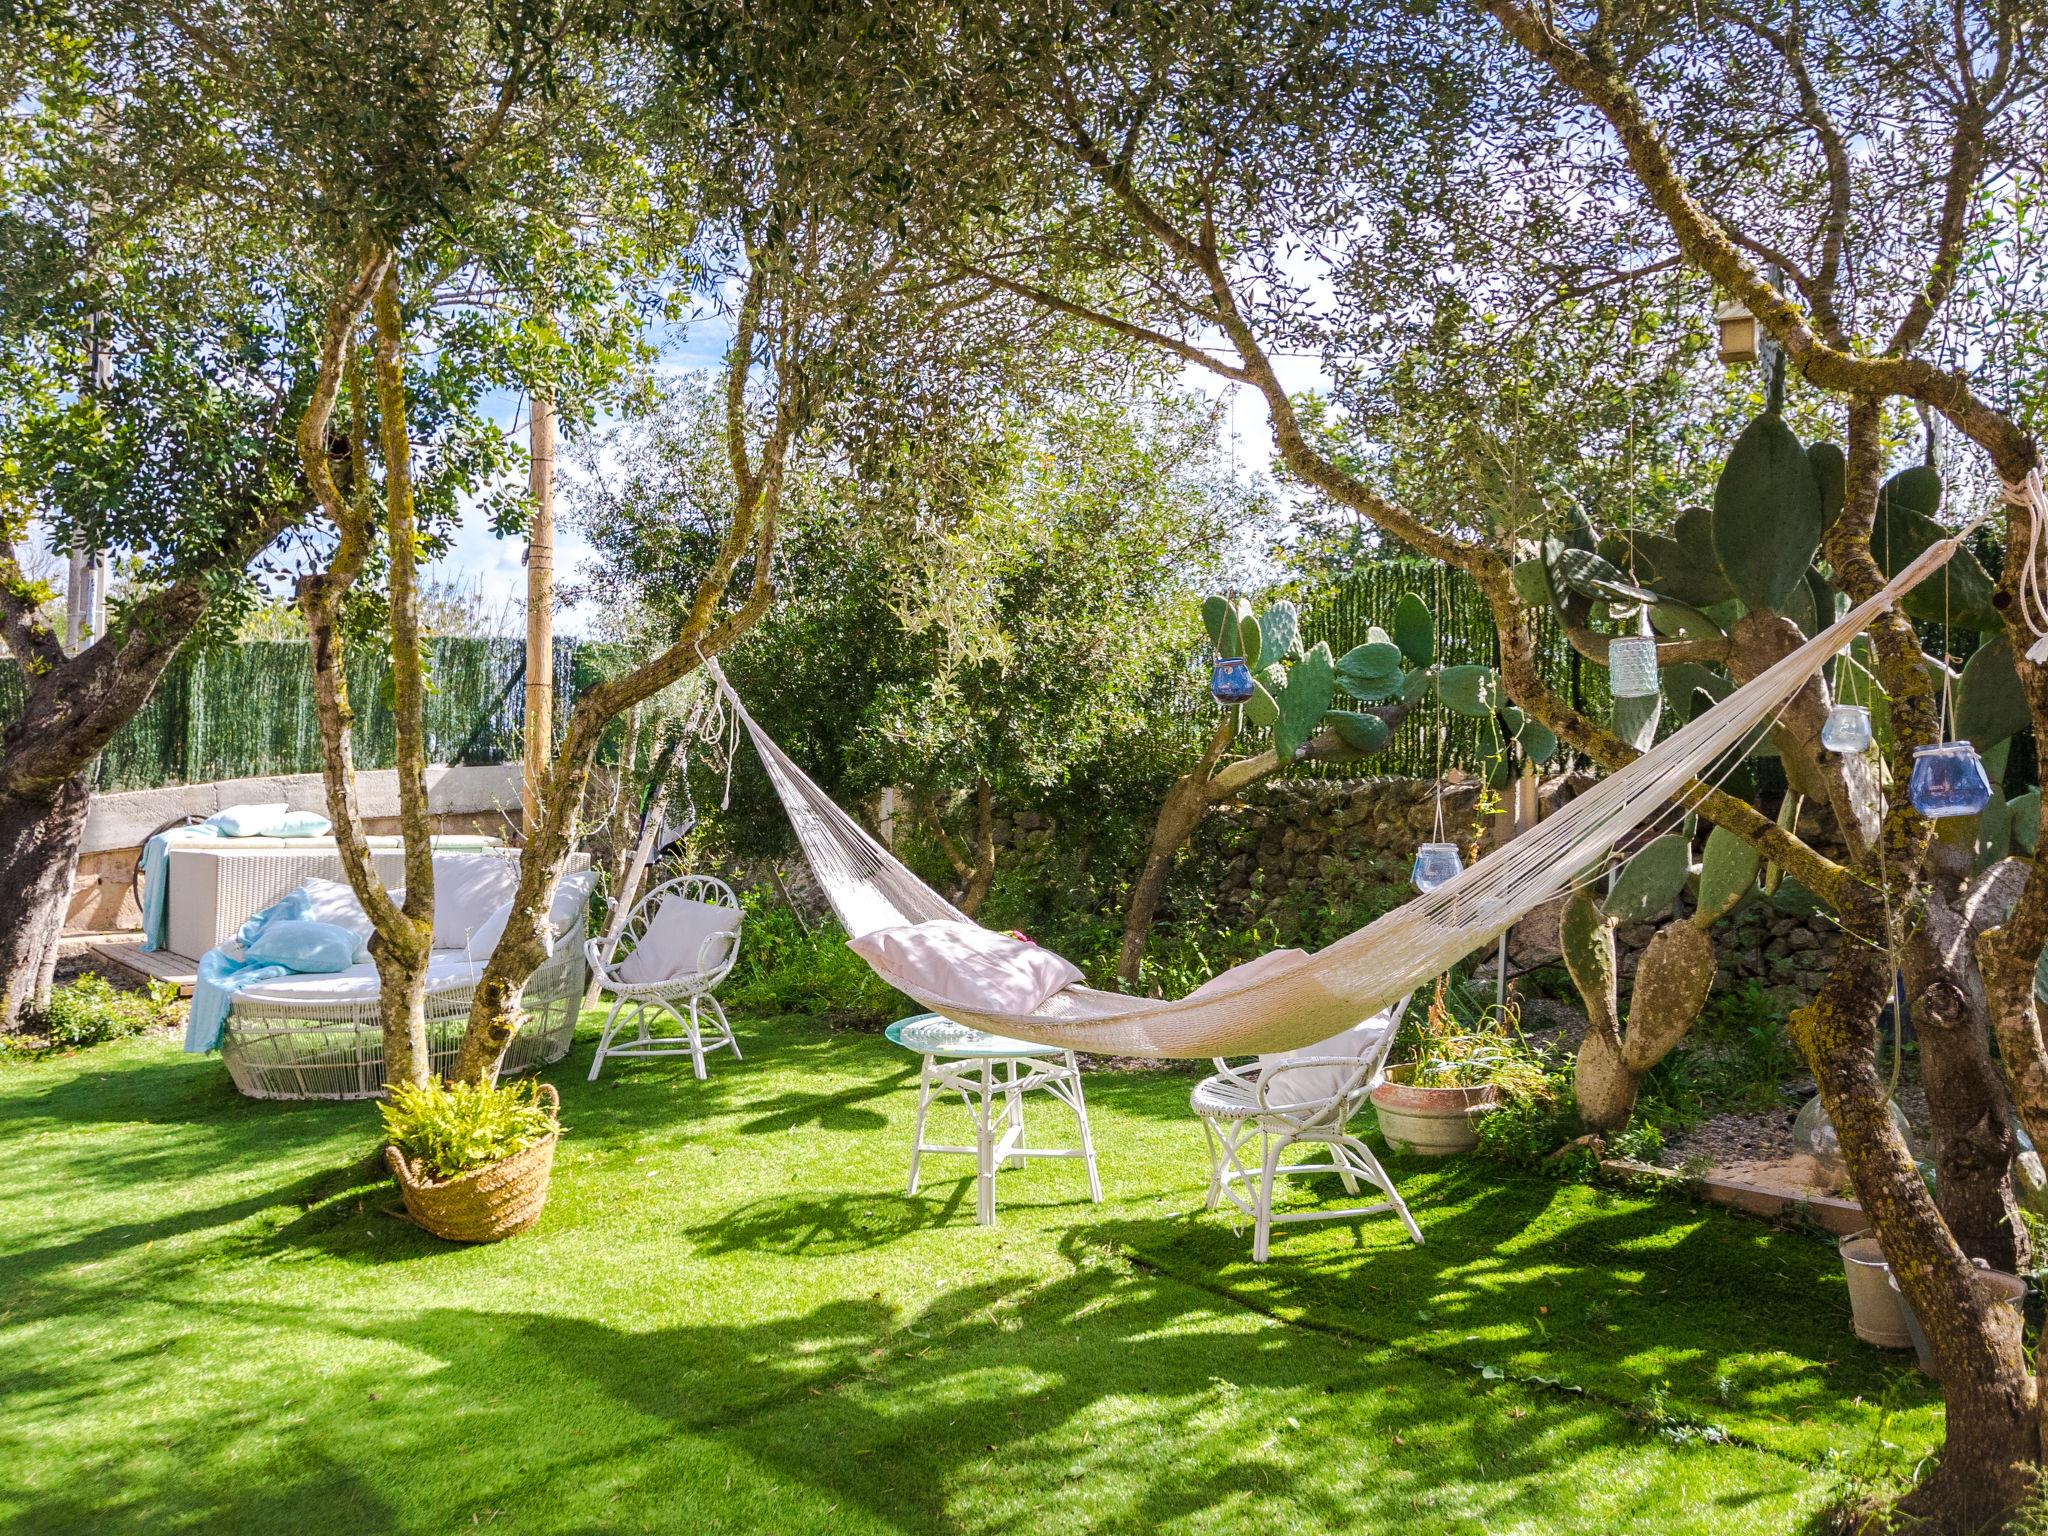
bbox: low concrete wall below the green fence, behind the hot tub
[63,764,520,934]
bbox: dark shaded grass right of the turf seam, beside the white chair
[1067,1157,1939,1460]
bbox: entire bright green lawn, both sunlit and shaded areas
[0,1020,1939,1536]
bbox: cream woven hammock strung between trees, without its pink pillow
[709,535,1960,1057]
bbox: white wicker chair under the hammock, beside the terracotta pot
[1188,997,1421,1264]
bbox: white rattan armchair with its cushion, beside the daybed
[584,874,741,1081]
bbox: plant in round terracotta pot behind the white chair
[1372,979,1540,1157]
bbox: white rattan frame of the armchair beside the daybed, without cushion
[584,874,741,1081]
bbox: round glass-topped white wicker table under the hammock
[883,1014,1102,1227]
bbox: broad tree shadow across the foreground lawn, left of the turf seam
[0,1264,1826,1536]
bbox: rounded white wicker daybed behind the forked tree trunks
[221,854,590,1100]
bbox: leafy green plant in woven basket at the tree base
[377,1081,561,1243]
